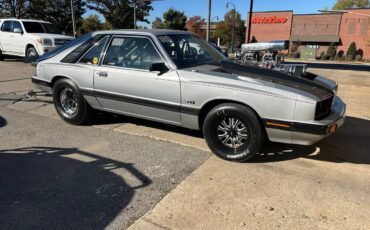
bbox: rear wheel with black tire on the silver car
[53,78,96,125]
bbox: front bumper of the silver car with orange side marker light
[264,96,346,145]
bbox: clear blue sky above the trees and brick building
[84,0,336,27]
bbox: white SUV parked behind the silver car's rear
[0,18,73,60]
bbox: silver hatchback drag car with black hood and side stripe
[32,30,346,161]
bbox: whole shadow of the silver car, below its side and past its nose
[94,113,370,164]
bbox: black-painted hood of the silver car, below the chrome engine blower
[186,61,334,99]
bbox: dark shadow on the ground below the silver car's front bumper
[252,117,370,164]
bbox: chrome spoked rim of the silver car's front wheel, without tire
[217,117,249,149]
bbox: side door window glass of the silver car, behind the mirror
[103,37,163,70]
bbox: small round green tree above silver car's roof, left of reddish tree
[163,8,187,30]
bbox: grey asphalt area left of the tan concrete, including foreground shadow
[0,61,210,229]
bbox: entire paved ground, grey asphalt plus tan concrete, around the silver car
[0,60,370,229]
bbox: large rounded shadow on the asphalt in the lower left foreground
[0,147,151,229]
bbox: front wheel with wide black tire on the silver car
[203,103,264,162]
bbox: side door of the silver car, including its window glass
[94,36,181,125]
